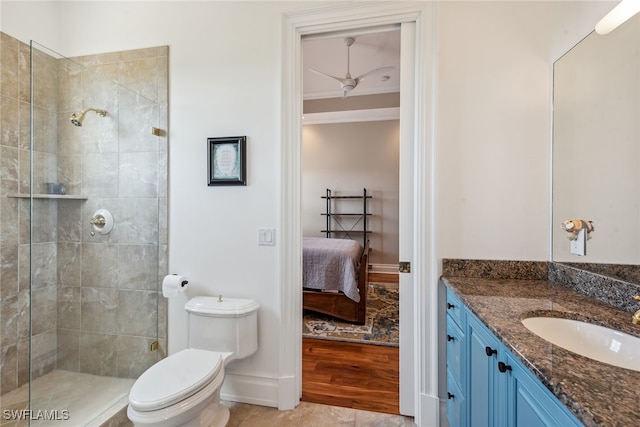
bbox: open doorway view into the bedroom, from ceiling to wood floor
[301,25,400,414]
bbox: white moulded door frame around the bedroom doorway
[278,2,440,424]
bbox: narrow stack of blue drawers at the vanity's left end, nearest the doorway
[446,290,467,427]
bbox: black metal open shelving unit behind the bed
[321,188,373,246]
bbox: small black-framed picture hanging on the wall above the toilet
[207,136,247,186]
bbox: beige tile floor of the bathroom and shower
[0,371,415,427]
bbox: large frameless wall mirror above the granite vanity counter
[552,16,640,280]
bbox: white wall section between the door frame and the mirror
[436,1,612,266]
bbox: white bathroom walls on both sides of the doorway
[2,1,611,418]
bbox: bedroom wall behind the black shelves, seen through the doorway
[301,120,400,265]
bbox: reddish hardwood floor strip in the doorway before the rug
[302,338,400,414]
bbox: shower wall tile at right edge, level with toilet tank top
[117,290,158,337]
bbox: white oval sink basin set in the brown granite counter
[522,317,640,371]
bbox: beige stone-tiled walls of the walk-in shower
[0,33,168,422]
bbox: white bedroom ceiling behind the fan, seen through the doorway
[302,28,400,99]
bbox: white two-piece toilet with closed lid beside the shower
[127,297,259,427]
